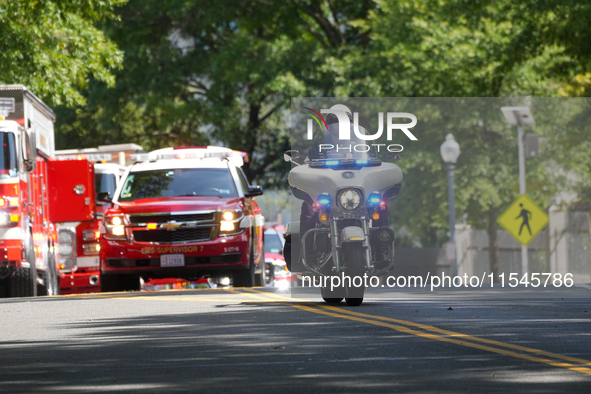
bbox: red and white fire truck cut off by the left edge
[0,85,94,297]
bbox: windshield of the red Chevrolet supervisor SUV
[119,168,238,201]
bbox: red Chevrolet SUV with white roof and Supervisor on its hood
[100,147,265,291]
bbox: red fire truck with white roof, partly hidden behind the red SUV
[55,144,143,294]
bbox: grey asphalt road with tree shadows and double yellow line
[0,285,591,393]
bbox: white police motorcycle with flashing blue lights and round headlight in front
[284,107,402,306]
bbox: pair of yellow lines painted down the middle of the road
[237,289,591,375]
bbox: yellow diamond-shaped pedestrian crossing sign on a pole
[497,194,550,245]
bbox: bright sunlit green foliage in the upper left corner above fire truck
[0,0,123,106]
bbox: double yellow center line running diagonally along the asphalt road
[248,290,591,375]
